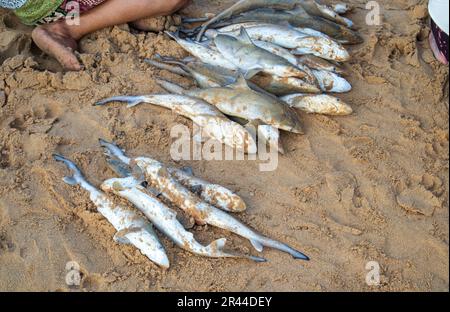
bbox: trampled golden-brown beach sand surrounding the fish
[0,0,449,291]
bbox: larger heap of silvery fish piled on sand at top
[97,0,362,153]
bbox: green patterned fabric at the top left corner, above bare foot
[14,0,64,25]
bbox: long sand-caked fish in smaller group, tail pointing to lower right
[133,157,309,260]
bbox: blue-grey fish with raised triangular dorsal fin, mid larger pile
[214,28,308,78]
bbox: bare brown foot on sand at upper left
[32,22,82,71]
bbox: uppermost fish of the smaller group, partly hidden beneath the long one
[99,139,247,212]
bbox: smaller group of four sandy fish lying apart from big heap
[54,140,309,268]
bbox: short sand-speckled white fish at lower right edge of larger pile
[281,94,353,116]
